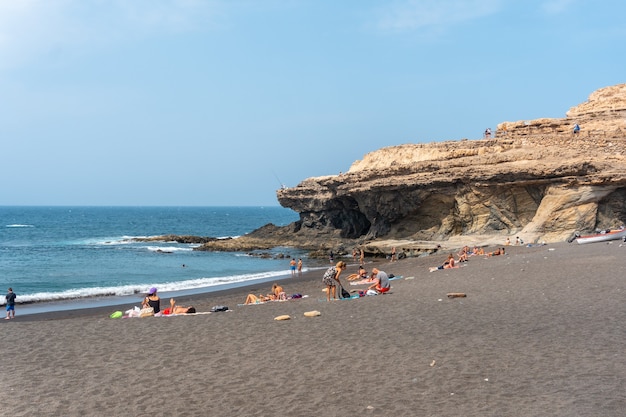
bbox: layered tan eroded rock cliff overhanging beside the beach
[277,84,626,242]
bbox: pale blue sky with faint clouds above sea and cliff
[0,0,626,206]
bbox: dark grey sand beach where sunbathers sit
[0,241,626,417]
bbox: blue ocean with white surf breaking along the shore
[0,206,321,312]
